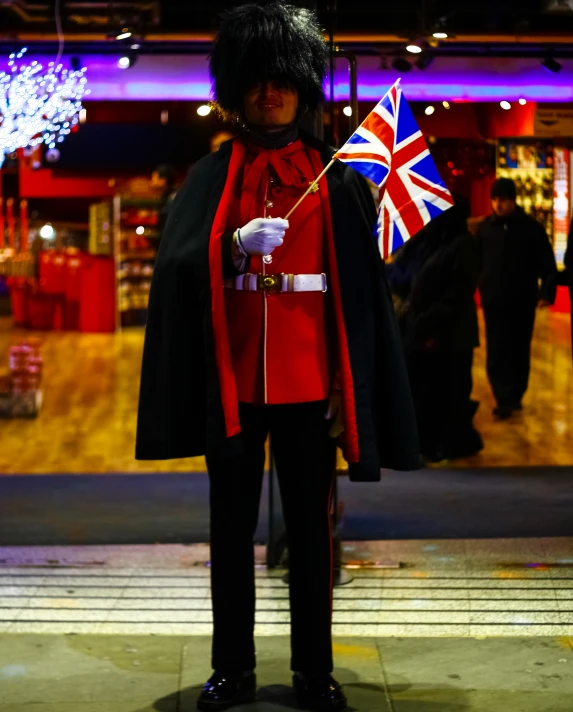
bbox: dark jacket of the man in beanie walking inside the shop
[477,207,557,311]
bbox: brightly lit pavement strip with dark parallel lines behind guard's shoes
[0,539,573,638]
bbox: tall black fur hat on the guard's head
[209,2,328,114]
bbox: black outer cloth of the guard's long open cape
[136,132,419,481]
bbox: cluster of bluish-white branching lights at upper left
[0,48,89,166]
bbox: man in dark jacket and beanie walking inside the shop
[477,178,557,420]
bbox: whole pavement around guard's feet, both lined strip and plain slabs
[0,539,573,712]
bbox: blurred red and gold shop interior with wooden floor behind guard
[0,100,573,474]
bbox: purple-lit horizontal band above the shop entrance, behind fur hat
[11,53,573,102]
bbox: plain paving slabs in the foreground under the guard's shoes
[0,634,573,712]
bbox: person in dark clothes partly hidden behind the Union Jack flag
[387,196,483,462]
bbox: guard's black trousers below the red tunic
[207,401,336,674]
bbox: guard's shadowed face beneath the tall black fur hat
[245,82,298,128]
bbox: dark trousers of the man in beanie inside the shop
[484,306,535,407]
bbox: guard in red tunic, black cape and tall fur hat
[136,3,420,710]
